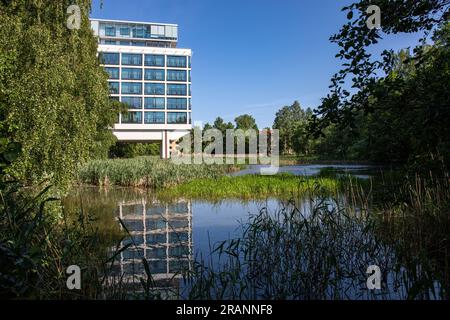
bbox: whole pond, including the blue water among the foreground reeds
[65,165,448,299]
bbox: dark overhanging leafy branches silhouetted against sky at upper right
[310,0,449,135]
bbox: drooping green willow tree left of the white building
[0,0,117,185]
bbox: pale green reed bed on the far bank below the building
[78,157,243,189]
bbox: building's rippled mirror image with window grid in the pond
[115,199,193,294]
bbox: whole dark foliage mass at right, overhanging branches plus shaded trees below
[309,0,450,168]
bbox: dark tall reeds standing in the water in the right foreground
[180,174,450,299]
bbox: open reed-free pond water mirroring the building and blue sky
[65,165,448,298]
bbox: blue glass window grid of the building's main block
[100,50,192,125]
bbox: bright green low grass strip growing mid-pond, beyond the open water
[159,174,340,200]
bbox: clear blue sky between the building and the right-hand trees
[91,0,417,128]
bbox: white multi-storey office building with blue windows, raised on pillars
[91,19,192,158]
